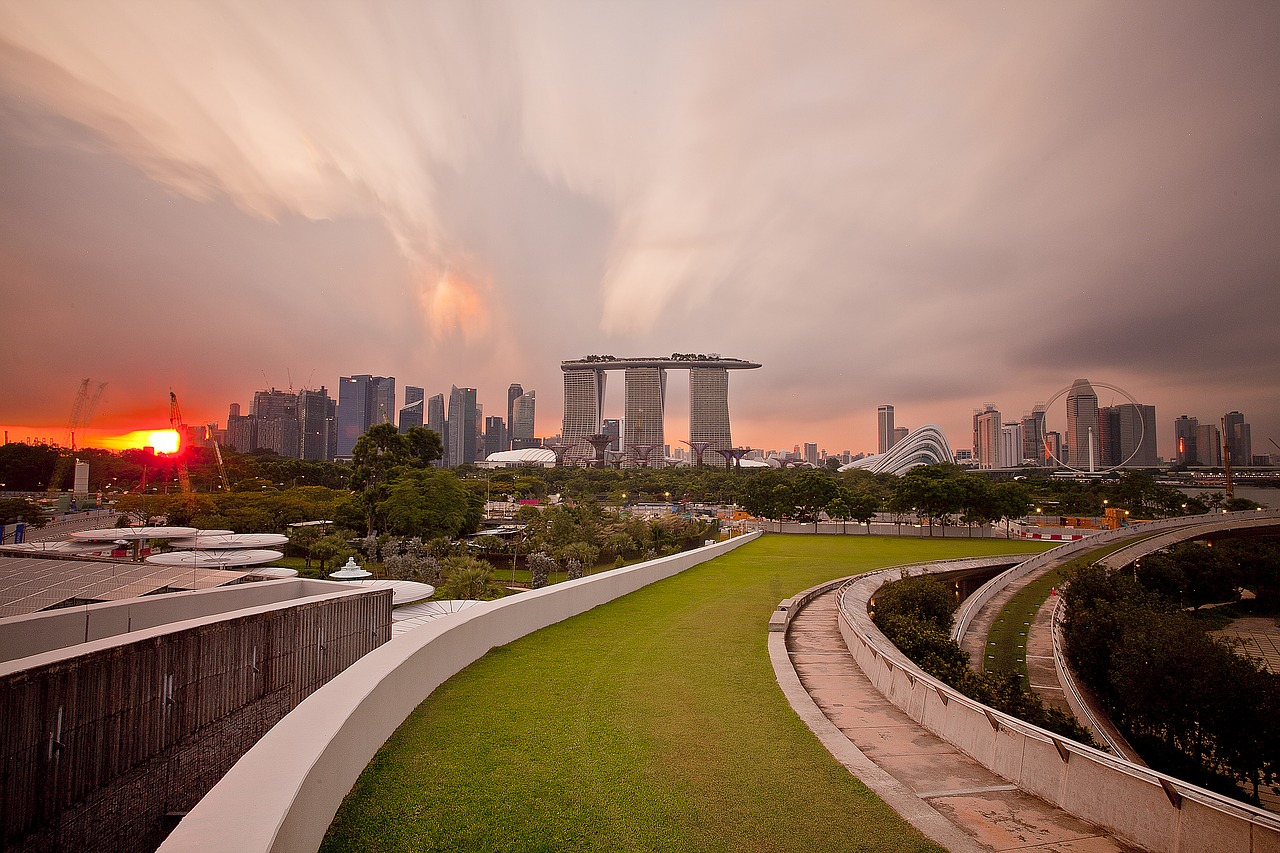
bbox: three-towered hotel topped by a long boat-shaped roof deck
[561,352,760,466]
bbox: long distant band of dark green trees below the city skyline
[0,438,1257,525]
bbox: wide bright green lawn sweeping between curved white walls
[321,535,1043,853]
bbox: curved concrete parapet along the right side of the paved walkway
[840,560,1280,853]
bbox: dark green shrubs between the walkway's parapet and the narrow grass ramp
[872,575,1093,745]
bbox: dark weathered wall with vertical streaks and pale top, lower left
[0,584,392,853]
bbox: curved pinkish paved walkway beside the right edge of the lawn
[780,593,1134,853]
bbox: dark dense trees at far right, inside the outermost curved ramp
[1064,539,1280,803]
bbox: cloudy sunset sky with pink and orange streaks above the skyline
[0,0,1280,457]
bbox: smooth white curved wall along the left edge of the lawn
[160,533,759,853]
